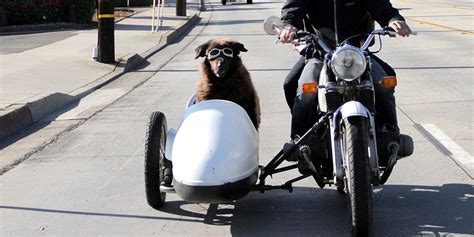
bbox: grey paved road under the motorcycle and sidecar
[0,0,474,236]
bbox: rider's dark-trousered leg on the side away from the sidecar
[372,60,399,132]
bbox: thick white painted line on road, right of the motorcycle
[421,124,474,178]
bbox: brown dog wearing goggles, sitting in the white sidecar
[196,39,260,130]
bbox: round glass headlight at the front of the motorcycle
[331,45,367,81]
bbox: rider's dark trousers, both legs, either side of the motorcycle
[283,55,398,138]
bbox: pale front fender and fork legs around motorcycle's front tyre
[329,101,380,186]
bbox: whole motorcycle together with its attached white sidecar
[145,17,414,236]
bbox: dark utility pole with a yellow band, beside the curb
[97,0,115,63]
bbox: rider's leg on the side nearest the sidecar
[291,58,323,139]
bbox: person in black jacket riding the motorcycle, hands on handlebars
[279,0,411,139]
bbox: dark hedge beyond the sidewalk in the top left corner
[0,0,95,25]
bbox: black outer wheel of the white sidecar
[145,112,167,209]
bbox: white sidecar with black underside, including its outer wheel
[145,97,259,207]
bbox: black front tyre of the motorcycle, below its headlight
[343,117,372,236]
